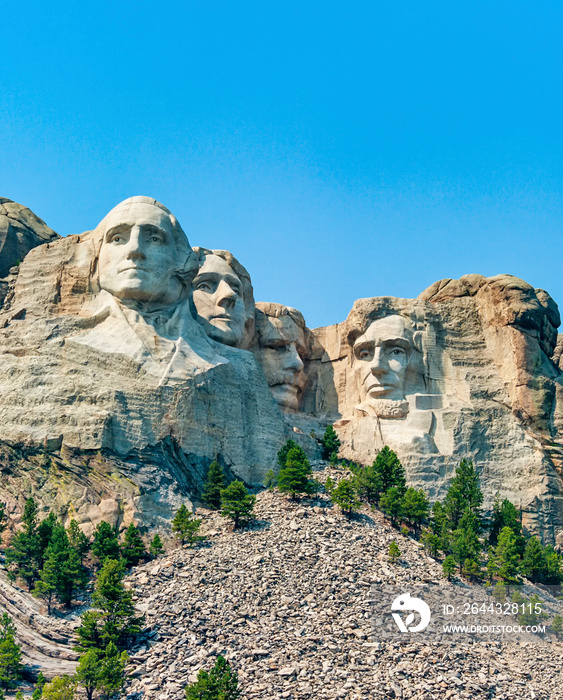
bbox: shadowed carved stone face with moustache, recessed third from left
[256,315,306,413]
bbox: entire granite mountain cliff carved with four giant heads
[0,197,563,542]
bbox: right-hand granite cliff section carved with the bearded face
[310,275,563,541]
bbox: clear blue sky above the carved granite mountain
[0,0,563,326]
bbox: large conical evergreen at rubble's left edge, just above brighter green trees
[77,559,142,651]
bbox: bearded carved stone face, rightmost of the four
[353,316,412,404]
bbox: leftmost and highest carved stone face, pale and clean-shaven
[98,203,182,305]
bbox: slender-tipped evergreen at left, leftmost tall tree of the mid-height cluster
[6,498,41,590]
